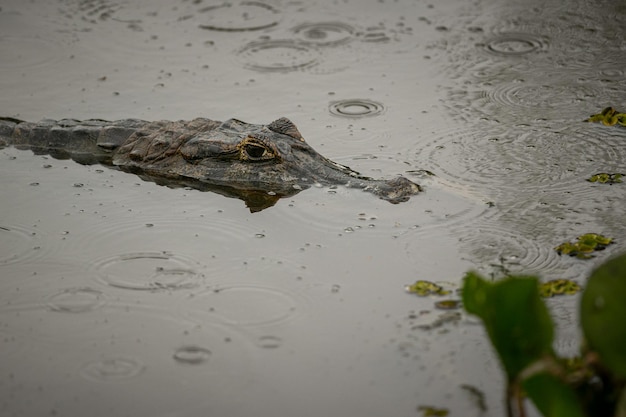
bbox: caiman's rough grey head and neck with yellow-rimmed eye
[113,118,421,208]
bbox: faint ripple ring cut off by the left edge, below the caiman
[0,224,42,266]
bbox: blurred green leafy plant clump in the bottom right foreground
[462,254,626,417]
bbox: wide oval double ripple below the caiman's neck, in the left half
[95,252,203,291]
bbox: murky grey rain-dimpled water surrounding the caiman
[0,0,626,416]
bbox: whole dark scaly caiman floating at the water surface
[0,117,421,211]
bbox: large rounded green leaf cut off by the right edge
[580,250,626,378]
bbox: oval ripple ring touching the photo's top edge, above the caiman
[198,1,280,32]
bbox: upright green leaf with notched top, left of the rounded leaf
[463,272,554,380]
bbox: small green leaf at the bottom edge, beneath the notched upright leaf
[522,373,585,417]
